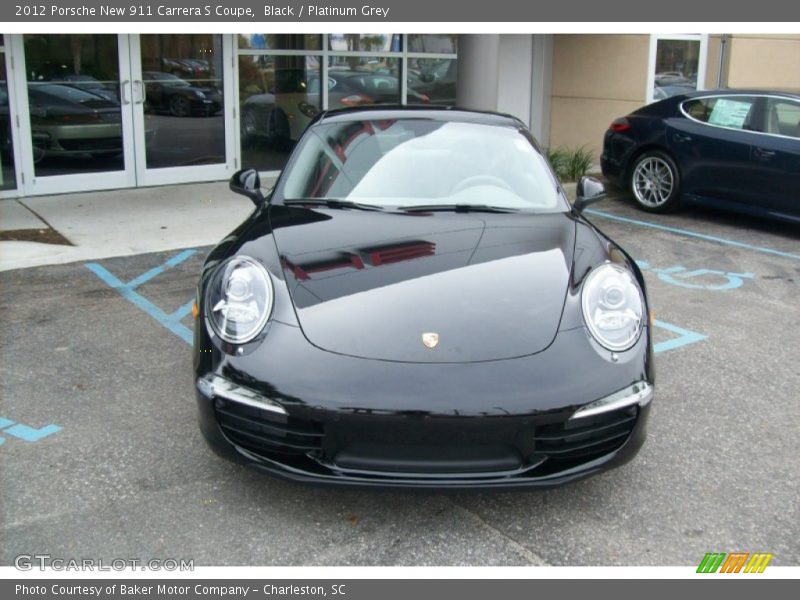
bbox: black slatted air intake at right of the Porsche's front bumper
[534,406,639,470]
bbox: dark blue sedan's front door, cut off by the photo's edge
[751,96,800,218]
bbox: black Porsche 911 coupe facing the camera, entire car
[194,107,654,488]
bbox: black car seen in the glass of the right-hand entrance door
[142,71,222,117]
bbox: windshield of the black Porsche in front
[281,119,566,212]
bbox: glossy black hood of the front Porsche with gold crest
[270,206,575,363]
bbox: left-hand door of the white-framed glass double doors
[9,34,135,194]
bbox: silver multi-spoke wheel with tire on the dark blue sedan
[630,150,681,213]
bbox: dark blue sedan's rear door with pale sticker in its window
[666,95,755,204]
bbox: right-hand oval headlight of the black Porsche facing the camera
[581,263,644,352]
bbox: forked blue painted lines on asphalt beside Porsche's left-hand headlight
[85,249,197,345]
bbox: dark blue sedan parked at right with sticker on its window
[601,90,800,221]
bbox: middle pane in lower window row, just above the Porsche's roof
[328,56,400,108]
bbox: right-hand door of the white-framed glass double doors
[130,34,235,185]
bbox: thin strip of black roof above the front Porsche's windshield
[311,104,527,129]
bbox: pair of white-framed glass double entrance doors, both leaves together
[7,34,237,195]
